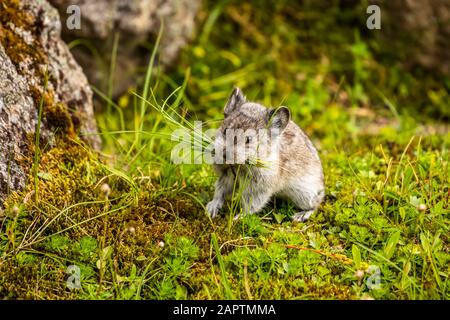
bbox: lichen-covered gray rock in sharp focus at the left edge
[0,0,100,207]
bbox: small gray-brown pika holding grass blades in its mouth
[207,88,325,222]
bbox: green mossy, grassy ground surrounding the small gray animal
[0,1,450,299]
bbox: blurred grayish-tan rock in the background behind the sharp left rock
[49,0,201,96]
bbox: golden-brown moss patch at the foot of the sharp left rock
[0,137,237,298]
